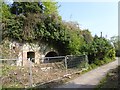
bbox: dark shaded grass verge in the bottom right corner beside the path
[95,66,120,90]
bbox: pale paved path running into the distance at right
[57,58,120,88]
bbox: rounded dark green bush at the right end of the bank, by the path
[81,36,115,63]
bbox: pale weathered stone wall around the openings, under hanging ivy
[10,41,58,66]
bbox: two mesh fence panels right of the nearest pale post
[33,55,88,87]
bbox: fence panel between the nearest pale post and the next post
[32,56,66,84]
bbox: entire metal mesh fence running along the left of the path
[0,55,88,87]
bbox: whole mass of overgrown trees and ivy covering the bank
[2,0,115,59]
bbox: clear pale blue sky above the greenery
[58,2,118,39]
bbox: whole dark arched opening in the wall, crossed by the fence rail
[44,51,58,63]
